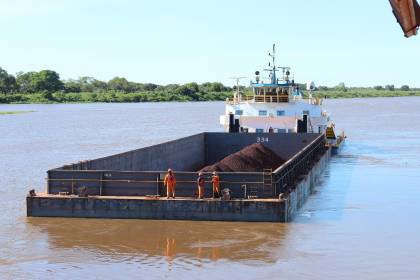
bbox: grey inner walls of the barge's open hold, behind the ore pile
[53,132,319,172]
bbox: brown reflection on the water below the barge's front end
[27,218,288,263]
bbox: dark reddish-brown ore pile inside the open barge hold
[200,143,285,172]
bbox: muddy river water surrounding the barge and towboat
[0,97,420,279]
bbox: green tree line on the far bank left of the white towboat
[0,68,232,103]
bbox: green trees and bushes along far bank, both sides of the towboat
[0,68,420,103]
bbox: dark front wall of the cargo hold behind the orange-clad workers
[46,169,274,198]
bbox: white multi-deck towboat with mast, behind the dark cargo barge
[220,45,331,133]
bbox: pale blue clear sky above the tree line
[0,0,420,87]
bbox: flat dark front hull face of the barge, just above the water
[27,197,284,222]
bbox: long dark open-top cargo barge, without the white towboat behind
[26,132,331,222]
